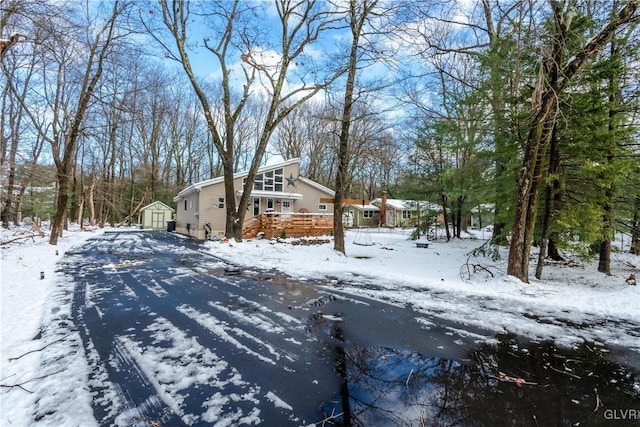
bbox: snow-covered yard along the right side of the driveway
[208,229,640,357]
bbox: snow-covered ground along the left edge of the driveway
[0,227,104,426]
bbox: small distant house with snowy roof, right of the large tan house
[371,193,442,227]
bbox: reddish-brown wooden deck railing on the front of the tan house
[242,212,333,239]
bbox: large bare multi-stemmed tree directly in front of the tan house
[152,0,348,240]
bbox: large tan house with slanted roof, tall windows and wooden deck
[173,159,335,239]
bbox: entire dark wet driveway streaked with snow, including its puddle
[10,232,640,426]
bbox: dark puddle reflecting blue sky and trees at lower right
[316,328,640,426]
